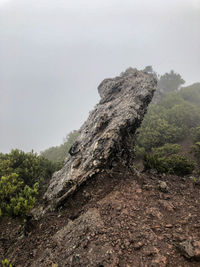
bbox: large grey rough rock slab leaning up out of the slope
[44,68,157,205]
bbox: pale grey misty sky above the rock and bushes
[0,0,200,152]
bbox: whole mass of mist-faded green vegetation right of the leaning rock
[136,70,200,175]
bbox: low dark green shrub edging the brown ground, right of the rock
[144,154,194,176]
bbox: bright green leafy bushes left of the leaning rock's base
[0,149,58,217]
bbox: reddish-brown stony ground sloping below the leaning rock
[0,169,200,267]
